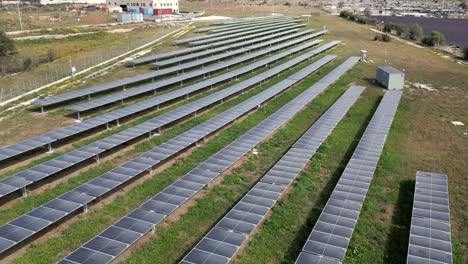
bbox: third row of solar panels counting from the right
[181,85,364,264]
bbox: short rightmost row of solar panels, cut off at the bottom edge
[406,171,452,264]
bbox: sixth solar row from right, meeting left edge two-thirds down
[0,43,334,201]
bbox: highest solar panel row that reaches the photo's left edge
[0,32,328,167]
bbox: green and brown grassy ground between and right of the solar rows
[0,5,468,263]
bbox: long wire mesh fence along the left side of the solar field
[0,25,182,103]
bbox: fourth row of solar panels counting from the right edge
[60,57,358,264]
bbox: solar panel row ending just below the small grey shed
[296,90,402,264]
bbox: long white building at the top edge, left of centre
[106,0,179,14]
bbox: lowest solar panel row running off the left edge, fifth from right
[0,55,333,253]
